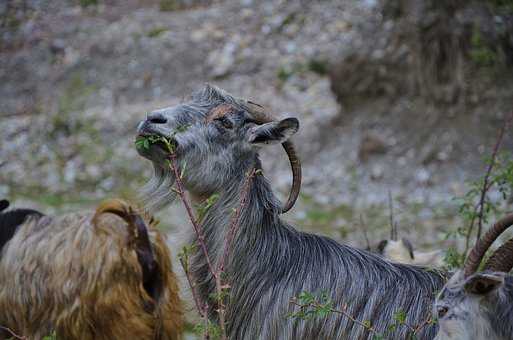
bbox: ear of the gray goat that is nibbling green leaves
[248,118,299,145]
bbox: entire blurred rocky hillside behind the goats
[0,0,513,306]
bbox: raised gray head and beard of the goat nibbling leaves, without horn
[137,85,299,208]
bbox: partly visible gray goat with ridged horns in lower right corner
[434,214,513,340]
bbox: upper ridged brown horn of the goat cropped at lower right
[463,214,513,277]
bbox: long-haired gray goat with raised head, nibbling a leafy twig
[138,85,445,340]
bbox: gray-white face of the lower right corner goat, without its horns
[433,271,511,340]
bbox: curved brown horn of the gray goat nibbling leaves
[246,101,301,214]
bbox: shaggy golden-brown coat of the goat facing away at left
[0,200,183,340]
